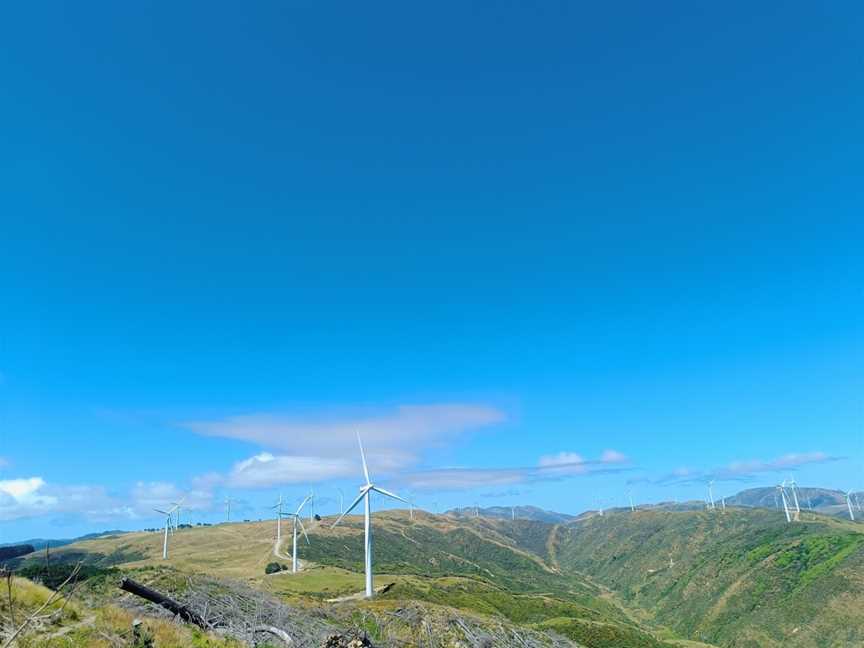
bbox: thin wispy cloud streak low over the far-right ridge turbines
[629,452,843,486]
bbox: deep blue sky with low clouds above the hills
[0,2,864,541]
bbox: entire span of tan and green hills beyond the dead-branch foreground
[11,507,864,648]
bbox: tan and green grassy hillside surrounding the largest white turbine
[11,512,671,648]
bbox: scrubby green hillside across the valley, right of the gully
[556,509,864,648]
